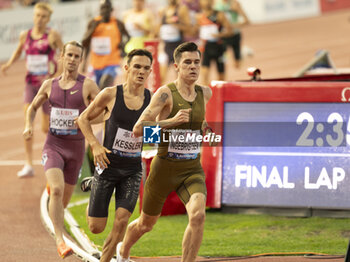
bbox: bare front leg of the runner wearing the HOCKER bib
[45,168,65,245]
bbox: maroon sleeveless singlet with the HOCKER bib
[49,74,86,140]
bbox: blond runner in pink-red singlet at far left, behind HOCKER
[1,3,63,177]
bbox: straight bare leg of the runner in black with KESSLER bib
[100,207,131,262]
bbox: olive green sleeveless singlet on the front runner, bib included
[157,83,205,160]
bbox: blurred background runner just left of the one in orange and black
[156,0,192,83]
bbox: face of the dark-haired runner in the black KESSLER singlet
[125,56,152,85]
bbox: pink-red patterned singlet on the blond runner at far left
[24,28,57,86]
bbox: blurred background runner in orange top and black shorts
[197,0,233,85]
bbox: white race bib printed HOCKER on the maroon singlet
[50,107,79,135]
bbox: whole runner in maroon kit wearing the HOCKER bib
[23,41,99,257]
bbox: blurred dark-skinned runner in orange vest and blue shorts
[82,0,129,89]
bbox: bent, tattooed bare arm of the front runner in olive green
[133,86,191,137]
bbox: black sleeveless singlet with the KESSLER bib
[103,85,151,167]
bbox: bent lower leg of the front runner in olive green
[117,211,160,258]
